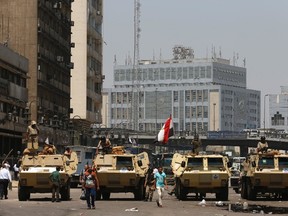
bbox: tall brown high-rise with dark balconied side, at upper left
[0,0,73,151]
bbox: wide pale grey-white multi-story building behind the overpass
[103,53,261,134]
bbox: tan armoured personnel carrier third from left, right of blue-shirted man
[171,153,230,201]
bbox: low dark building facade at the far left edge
[0,44,29,157]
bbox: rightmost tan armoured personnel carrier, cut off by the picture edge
[241,151,288,200]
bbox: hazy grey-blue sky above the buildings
[103,0,288,100]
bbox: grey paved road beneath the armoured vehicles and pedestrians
[0,184,288,216]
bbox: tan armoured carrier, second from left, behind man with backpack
[93,147,149,200]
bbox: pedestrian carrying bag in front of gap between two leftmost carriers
[82,168,99,209]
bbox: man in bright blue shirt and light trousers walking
[154,167,168,207]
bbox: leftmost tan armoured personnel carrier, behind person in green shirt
[18,145,78,201]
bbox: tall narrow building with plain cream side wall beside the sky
[70,0,104,123]
